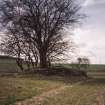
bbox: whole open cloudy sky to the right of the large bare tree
[73,0,105,64]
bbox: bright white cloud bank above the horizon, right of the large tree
[73,28,105,63]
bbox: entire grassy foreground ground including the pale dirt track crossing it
[0,72,105,105]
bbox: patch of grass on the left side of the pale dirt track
[0,77,63,105]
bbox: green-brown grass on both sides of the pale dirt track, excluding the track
[0,76,105,105]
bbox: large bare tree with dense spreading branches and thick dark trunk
[0,0,81,68]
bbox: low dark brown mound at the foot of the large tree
[35,66,87,77]
